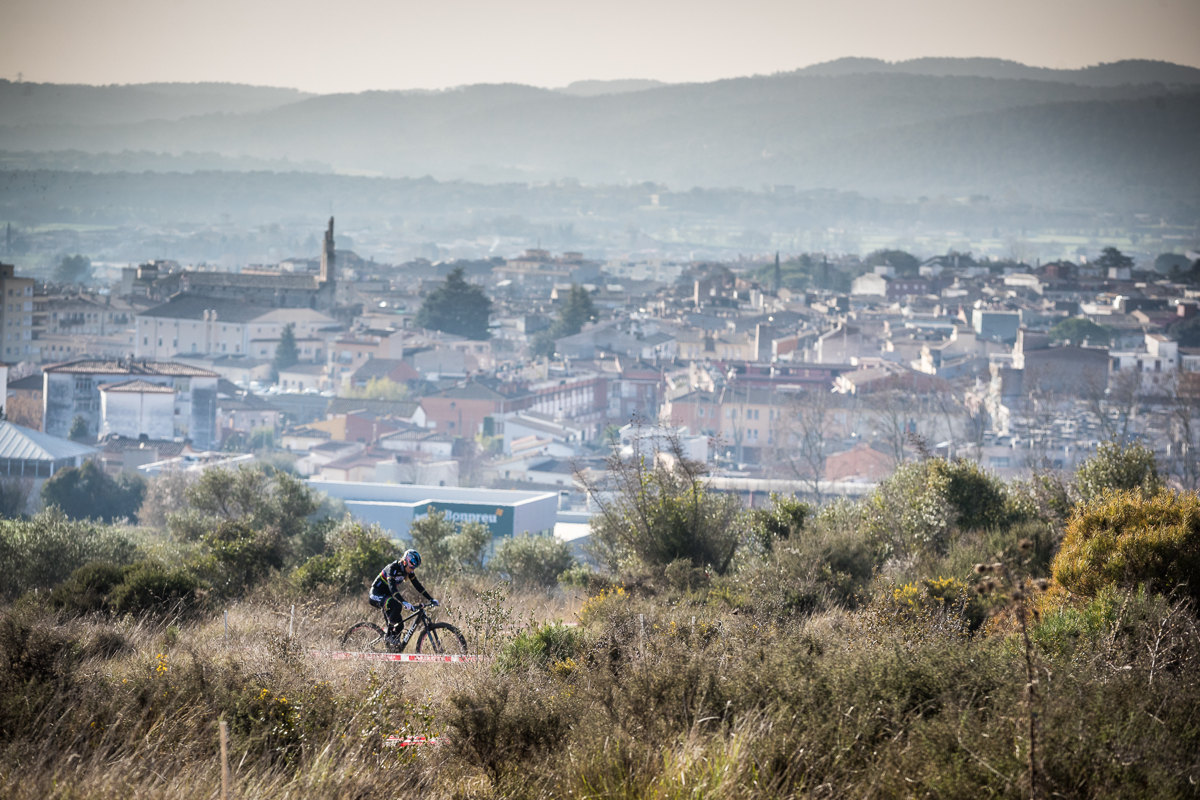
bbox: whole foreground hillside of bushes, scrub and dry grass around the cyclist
[0,444,1200,800]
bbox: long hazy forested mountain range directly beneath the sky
[0,59,1200,206]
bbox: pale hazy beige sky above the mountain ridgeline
[0,0,1200,92]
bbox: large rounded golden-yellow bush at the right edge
[1051,491,1200,600]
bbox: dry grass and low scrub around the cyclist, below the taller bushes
[0,581,1200,800]
